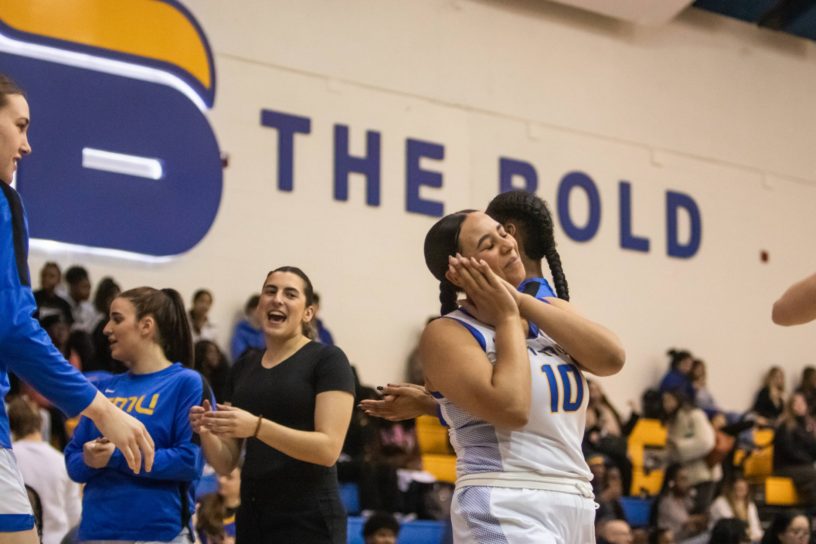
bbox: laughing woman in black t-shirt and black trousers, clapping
[190,267,354,544]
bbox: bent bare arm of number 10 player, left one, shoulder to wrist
[419,316,531,428]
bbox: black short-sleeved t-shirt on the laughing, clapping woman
[230,342,354,488]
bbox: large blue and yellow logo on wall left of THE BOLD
[0,0,222,257]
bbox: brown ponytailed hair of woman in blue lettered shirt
[119,287,194,368]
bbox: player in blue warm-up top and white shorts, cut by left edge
[0,74,153,544]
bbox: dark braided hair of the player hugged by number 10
[485,190,569,300]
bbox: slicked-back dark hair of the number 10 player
[425,210,476,315]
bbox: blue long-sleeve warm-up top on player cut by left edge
[0,181,96,448]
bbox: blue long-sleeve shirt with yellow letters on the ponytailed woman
[65,363,215,541]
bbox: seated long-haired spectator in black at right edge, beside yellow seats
[773,392,816,504]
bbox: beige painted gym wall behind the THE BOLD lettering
[31,0,816,409]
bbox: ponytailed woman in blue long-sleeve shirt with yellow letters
[65,287,212,543]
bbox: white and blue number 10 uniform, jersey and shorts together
[434,310,595,544]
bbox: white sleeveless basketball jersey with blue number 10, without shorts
[434,310,592,482]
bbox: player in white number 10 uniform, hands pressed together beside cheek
[420,211,624,544]
